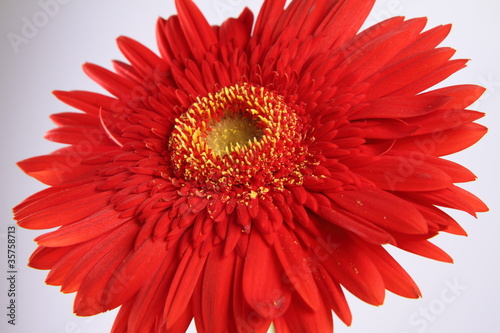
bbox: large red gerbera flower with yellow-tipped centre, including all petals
[15,0,487,333]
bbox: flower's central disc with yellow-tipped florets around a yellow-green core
[169,83,310,199]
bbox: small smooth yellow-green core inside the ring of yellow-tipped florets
[206,115,262,156]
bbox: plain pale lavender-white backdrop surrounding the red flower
[0,0,500,333]
